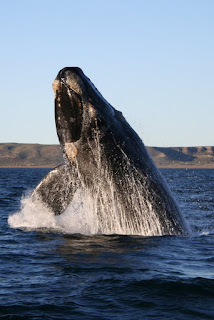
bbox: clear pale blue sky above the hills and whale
[0,0,214,146]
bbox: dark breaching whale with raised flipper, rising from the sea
[31,67,189,235]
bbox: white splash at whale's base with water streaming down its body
[8,133,186,236]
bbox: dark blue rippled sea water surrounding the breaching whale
[0,169,214,320]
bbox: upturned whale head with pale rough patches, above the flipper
[53,67,118,161]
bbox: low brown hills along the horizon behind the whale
[0,143,214,168]
